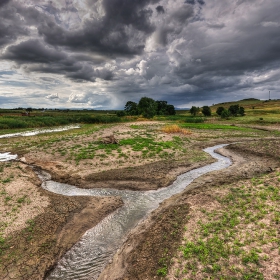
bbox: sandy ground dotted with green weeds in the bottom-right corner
[164,170,280,279]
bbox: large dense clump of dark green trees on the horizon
[117,97,176,118]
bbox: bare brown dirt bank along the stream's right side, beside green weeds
[98,140,280,280]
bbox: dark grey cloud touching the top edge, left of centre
[38,0,159,55]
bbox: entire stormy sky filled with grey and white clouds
[0,0,280,110]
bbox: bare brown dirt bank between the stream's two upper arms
[32,157,214,191]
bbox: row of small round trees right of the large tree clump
[190,104,245,118]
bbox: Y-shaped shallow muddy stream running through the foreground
[42,145,231,280]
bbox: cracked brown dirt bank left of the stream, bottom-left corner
[0,162,123,280]
